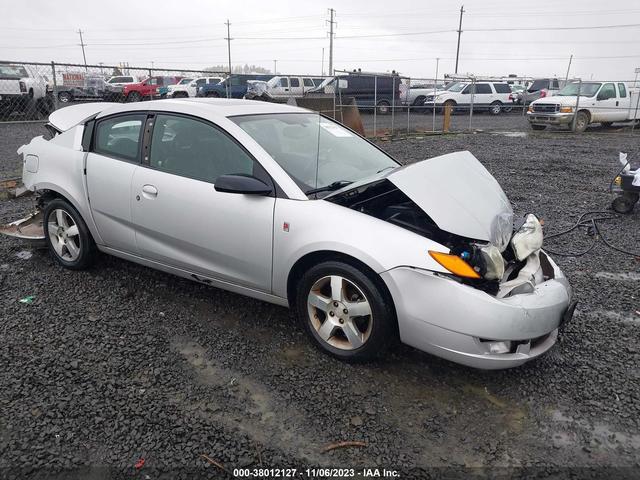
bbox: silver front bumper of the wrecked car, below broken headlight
[381,252,575,369]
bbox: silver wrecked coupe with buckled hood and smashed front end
[7,99,575,369]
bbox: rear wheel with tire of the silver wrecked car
[43,198,95,270]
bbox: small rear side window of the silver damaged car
[93,115,146,161]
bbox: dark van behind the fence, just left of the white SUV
[307,72,402,115]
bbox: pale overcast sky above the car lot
[5,0,640,80]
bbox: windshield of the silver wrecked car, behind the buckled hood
[231,113,398,193]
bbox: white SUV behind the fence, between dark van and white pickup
[424,81,512,115]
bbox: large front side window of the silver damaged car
[149,115,260,183]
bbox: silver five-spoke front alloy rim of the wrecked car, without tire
[307,275,373,350]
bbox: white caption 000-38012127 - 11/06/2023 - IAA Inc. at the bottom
[233,468,400,478]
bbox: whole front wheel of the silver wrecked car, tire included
[296,261,396,362]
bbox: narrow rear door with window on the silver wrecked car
[87,113,146,253]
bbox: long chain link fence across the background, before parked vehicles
[0,61,640,137]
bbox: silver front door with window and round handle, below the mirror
[132,114,275,292]
